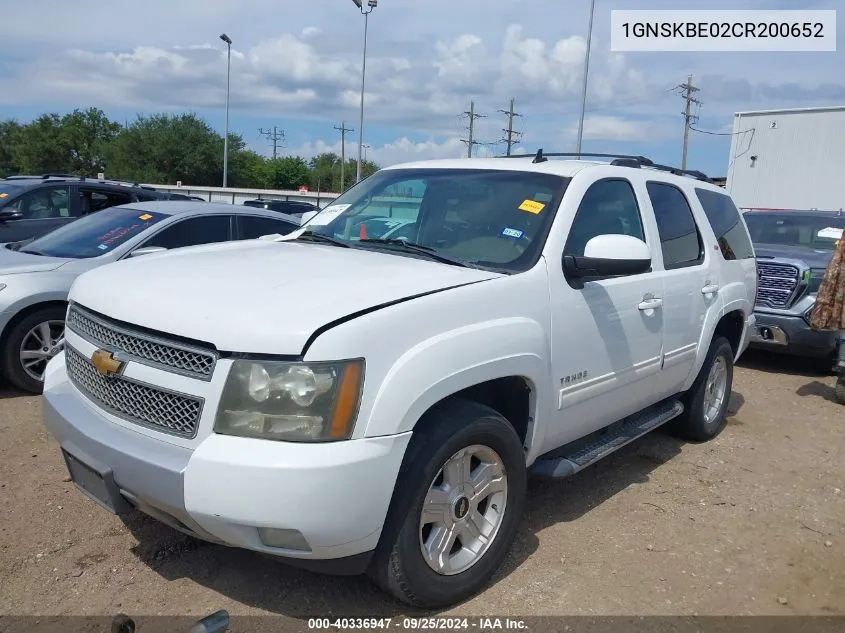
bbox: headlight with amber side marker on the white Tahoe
[214,360,364,442]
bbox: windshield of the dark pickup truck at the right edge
[745,211,845,251]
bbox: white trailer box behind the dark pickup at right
[726,105,845,211]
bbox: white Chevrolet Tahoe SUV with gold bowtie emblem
[43,150,757,608]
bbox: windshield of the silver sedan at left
[20,207,169,259]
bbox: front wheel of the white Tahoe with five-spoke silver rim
[370,400,527,609]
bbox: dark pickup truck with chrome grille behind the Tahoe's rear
[743,210,845,372]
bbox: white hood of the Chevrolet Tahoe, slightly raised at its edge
[70,240,501,354]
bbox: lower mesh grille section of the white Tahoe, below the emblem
[65,344,203,439]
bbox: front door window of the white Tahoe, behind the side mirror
[564,179,645,256]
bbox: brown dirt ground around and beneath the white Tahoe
[0,352,845,630]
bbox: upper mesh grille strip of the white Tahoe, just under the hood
[66,303,218,382]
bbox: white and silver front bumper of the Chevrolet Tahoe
[43,354,411,573]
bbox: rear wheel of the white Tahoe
[668,336,734,442]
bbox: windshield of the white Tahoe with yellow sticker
[305,169,569,272]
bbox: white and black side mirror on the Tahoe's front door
[563,235,651,282]
